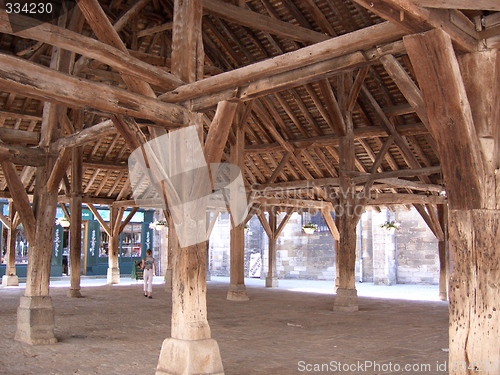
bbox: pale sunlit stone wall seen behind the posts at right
[203,209,439,285]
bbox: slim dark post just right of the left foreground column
[68,147,83,298]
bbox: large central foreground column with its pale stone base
[156,0,224,375]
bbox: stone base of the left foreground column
[15,296,57,345]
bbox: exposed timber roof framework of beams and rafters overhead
[0,0,500,214]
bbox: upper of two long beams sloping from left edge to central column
[0,9,183,89]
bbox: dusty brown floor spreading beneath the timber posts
[0,277,448,375]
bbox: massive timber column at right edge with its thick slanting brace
[404,30,500,375]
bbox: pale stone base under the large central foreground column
[156,338,224,375]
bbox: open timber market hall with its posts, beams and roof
[0,0,500,374]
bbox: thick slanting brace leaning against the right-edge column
[404,30,485,209]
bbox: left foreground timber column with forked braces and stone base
[6,104,61,345]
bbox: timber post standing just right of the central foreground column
[227,106,249,301]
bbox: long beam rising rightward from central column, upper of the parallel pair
[159,23,405,103]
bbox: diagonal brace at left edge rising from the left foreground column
[0,161,36,243]
